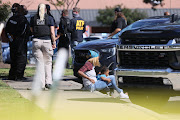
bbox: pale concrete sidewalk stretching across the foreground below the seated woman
[5,76,180,120]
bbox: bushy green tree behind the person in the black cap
[96,5,147,26]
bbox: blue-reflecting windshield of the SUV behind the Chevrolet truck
[112,19,169,39]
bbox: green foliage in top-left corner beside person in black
[0,0,11,21]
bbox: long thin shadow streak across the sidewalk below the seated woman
[68,98,129,104]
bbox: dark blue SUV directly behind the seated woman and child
[73,16,172,77]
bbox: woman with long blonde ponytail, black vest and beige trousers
[30,4,56,89]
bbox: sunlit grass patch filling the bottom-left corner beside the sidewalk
[0,80,52,120]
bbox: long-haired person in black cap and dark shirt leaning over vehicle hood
[108,7,127,38]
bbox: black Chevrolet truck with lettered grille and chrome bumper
[115,14,180,104]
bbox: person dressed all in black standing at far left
[5,3,30,80]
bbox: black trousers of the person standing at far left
[9,38,27,79]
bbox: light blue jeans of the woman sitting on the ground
[94,75,123,93]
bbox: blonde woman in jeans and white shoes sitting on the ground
[78,57,129,98]
